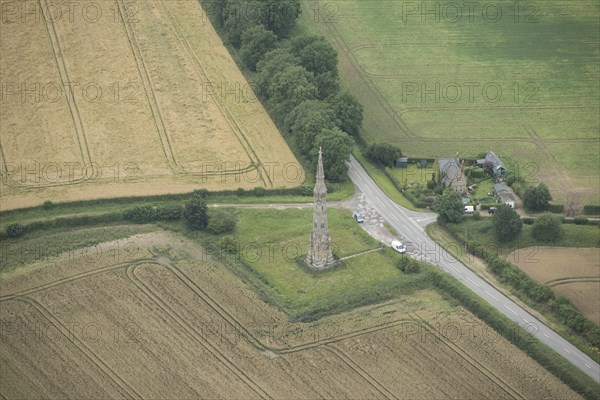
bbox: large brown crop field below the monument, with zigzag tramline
[0,232,578,399]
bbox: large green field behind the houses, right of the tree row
[299,0,600,205]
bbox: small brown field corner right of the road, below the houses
[508,247,600,325]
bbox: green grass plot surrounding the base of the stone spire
[224,209,431,319]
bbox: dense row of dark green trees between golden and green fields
[204,0,363,182]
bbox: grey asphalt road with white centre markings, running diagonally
[348,156,600,382]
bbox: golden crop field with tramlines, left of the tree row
[0,0,304,210]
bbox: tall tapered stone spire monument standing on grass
[306,147,335,269]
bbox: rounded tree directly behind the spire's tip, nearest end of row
[310,127,354,182]
